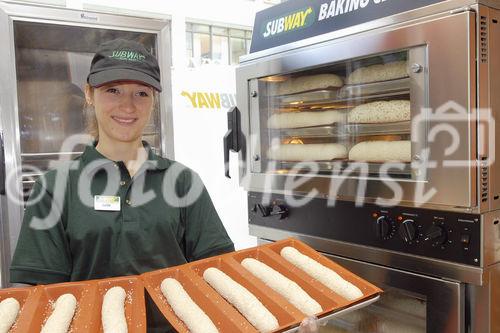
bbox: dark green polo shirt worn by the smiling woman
[10,144,234,284]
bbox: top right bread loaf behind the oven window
[346,61,408,84]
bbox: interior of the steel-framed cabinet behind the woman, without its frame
[13,21,161,198]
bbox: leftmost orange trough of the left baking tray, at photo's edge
[0,287,40,333]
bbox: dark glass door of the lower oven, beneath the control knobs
[321,255,465,333]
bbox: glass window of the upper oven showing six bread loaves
[250,46,427,179]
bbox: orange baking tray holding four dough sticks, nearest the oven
[141,239,382,333]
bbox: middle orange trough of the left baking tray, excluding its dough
[22,281,96,333]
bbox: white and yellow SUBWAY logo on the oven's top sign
[262,7,314,38]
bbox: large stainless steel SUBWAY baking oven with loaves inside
[229,0,500,333]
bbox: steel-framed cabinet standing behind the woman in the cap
[0,2,173,287]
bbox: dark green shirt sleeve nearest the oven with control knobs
[183,170,234,261]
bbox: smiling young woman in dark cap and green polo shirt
[10,39,234,284]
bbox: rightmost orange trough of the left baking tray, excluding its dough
[91,276,147,333]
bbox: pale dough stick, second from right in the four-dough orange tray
[241,258,323,316]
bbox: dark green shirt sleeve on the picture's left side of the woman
[10,181,72,284]
